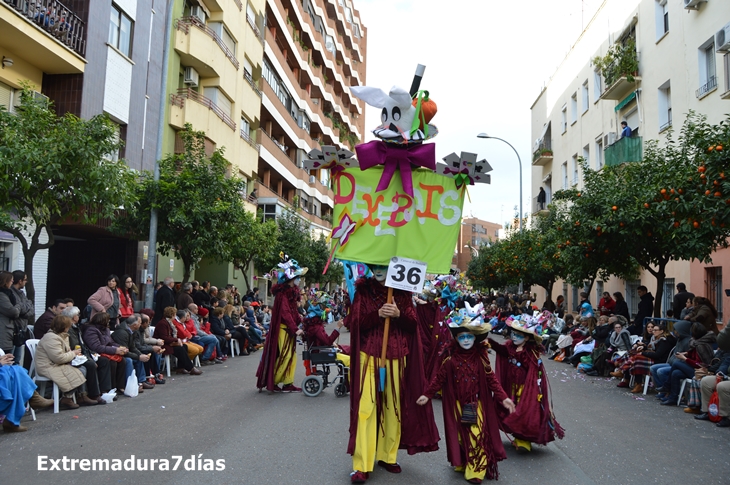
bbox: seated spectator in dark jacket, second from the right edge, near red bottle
[661,322,717,406]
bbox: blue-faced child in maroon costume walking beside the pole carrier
[416,318,515,483]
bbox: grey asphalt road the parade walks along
[0,328,730,485]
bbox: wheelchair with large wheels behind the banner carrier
[302,343,350,397]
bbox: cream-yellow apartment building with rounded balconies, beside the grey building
[156,0,265,286]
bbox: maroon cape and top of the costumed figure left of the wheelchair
[256,283,302,391]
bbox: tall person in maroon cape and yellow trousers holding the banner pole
[345,266,439,483]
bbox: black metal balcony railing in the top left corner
[4,0,86,57]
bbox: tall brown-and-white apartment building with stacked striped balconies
[256,0,367,236]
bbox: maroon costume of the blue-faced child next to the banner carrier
[425,341,507,480]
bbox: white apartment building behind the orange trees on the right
[531,0,730,319]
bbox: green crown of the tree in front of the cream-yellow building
[115,124,246,282]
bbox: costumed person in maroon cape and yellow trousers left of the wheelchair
[256,253,307,392]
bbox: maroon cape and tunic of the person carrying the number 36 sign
[345,278,439,455]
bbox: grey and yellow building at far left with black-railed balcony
[0,0,166,315]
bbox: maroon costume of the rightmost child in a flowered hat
[489,337,565,445]
